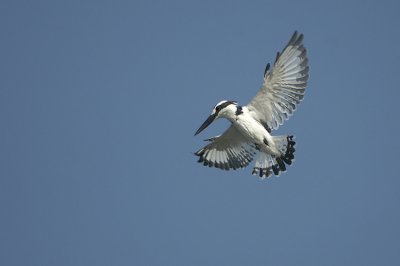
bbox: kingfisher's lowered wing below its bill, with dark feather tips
[195,125,256,170]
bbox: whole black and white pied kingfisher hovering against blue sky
[195,32,309,178]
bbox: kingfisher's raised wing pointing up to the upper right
[247,32,309,130]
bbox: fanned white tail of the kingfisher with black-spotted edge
[253,136,296,179]
